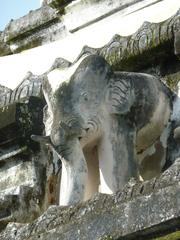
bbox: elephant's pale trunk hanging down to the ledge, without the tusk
[51,122,88,206]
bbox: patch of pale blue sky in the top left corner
[0,0,40,31]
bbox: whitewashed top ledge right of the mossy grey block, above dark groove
[63,0,159,32]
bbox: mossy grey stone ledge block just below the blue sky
[0,6,66,56]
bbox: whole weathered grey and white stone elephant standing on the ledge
[33,55,171,205]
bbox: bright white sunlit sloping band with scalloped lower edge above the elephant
[0,0,180,89]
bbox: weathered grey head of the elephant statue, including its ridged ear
[43,55,133,146]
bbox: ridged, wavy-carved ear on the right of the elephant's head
[107,73,134,115]
